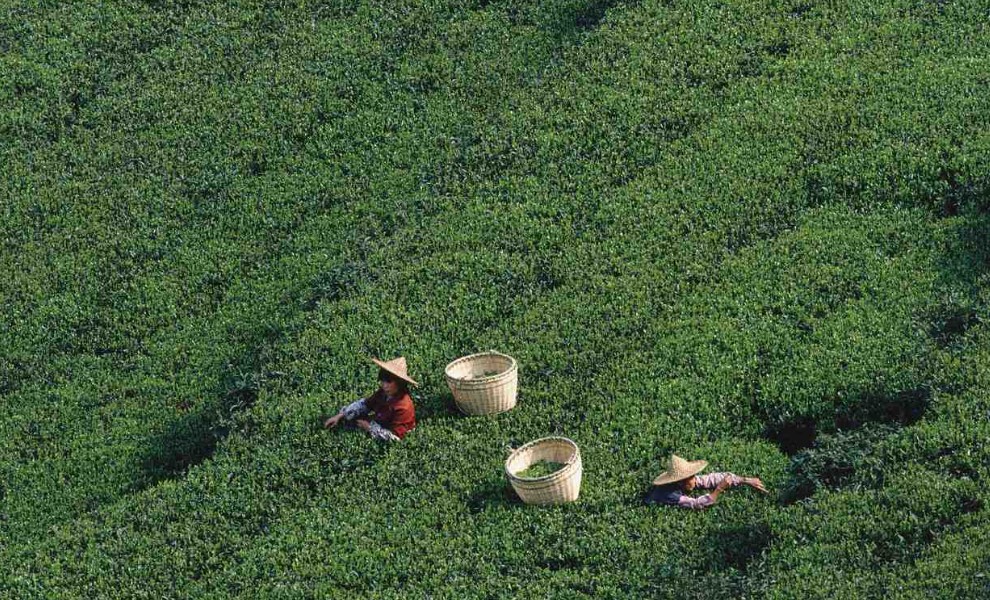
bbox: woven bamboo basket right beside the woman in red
[444,350,519,415]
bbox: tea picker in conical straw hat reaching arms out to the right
[646,454,770,510]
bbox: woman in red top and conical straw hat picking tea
[323,356,419,442]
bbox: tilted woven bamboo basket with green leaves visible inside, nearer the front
[505,437,583,504]
